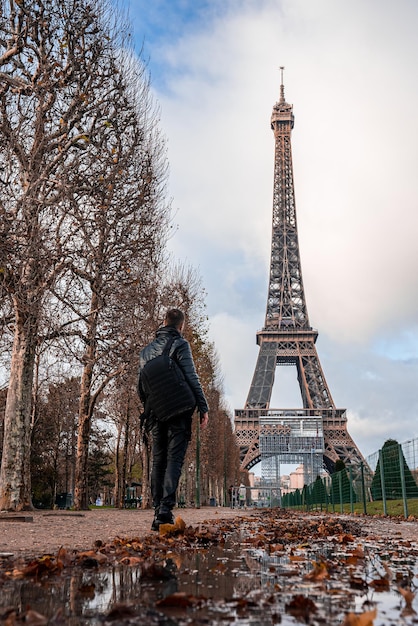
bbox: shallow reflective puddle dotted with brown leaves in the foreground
[0,516,418,626]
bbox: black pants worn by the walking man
[151,411,193,513]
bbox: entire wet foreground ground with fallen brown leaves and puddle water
[0,511,418,626]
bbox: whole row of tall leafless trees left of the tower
[0,0,240,510]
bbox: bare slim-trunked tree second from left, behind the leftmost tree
[63,65,168,508]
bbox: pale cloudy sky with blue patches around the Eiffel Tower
[118,0,418,456]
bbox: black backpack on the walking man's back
[141,337,196,422]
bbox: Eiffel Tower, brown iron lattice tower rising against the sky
[234,67,364,478]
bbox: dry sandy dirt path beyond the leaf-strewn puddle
[0,507,418,559]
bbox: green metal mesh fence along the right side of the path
[281,439,418,518]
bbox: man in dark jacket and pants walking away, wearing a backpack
[138,309,209,531]
